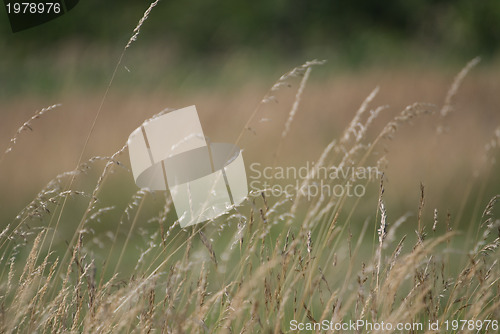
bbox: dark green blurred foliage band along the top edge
[0,0,500,61]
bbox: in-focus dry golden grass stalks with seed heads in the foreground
[0,57,500,333]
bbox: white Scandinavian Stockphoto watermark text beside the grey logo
[248,161,380,200]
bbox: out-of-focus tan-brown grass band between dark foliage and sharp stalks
[0,55,500,227]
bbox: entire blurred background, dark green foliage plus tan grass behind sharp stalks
[0,0,500,240]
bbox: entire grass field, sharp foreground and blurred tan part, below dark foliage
[0,5,500,333]
